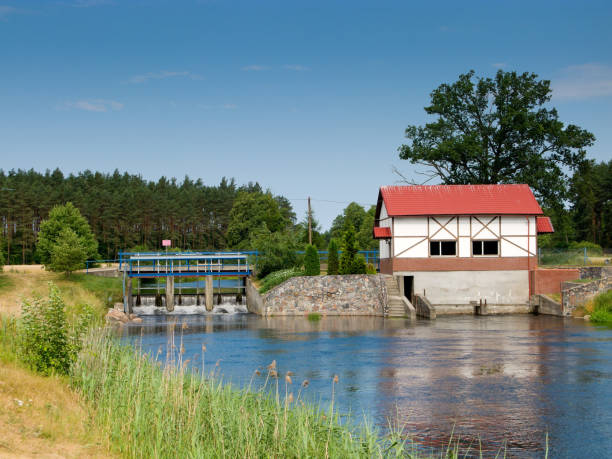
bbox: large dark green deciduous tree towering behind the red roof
[399,70,595,205]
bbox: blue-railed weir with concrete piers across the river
[119,252,257,313]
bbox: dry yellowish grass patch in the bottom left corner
[0,316,116,458]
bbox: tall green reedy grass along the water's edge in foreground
[72,333,464,458]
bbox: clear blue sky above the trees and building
[0,0,612,227]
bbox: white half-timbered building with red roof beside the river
[374,185,552,313]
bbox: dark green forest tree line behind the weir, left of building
[0,169,377,264]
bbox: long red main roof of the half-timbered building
[377,185,542,218]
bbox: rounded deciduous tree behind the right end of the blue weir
[227,192,291,250]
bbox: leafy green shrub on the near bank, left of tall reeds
[17,284,94,374]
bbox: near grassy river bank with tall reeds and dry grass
[0,272,468,457]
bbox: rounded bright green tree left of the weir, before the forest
[37,202,98,269]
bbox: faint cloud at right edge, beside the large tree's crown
[551,63,612,100]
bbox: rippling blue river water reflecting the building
[119,307,612,458]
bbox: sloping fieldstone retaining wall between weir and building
[262,274,387,316]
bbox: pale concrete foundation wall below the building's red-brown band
[394,270,529,308]
